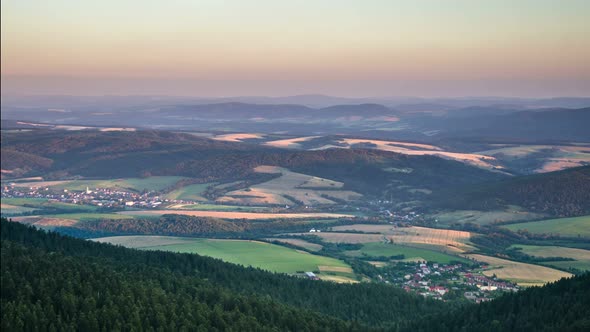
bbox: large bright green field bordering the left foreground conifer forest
[95,236,352,273]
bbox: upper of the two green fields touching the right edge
[503,216,590,237]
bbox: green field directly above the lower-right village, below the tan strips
[358,242,467,264]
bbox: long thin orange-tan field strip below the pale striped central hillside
[117,210,352,219]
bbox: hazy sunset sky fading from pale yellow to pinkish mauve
[1,0,590,97]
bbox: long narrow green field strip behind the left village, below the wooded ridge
[15,176,184,192]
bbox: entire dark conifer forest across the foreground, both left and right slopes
[0,220,590,331]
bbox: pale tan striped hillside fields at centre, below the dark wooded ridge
[218,166,362,205]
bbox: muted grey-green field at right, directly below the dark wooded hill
[430,206,545,225]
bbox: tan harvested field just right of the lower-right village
[468,254,572,286]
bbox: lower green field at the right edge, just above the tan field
[510,244,590,271]
